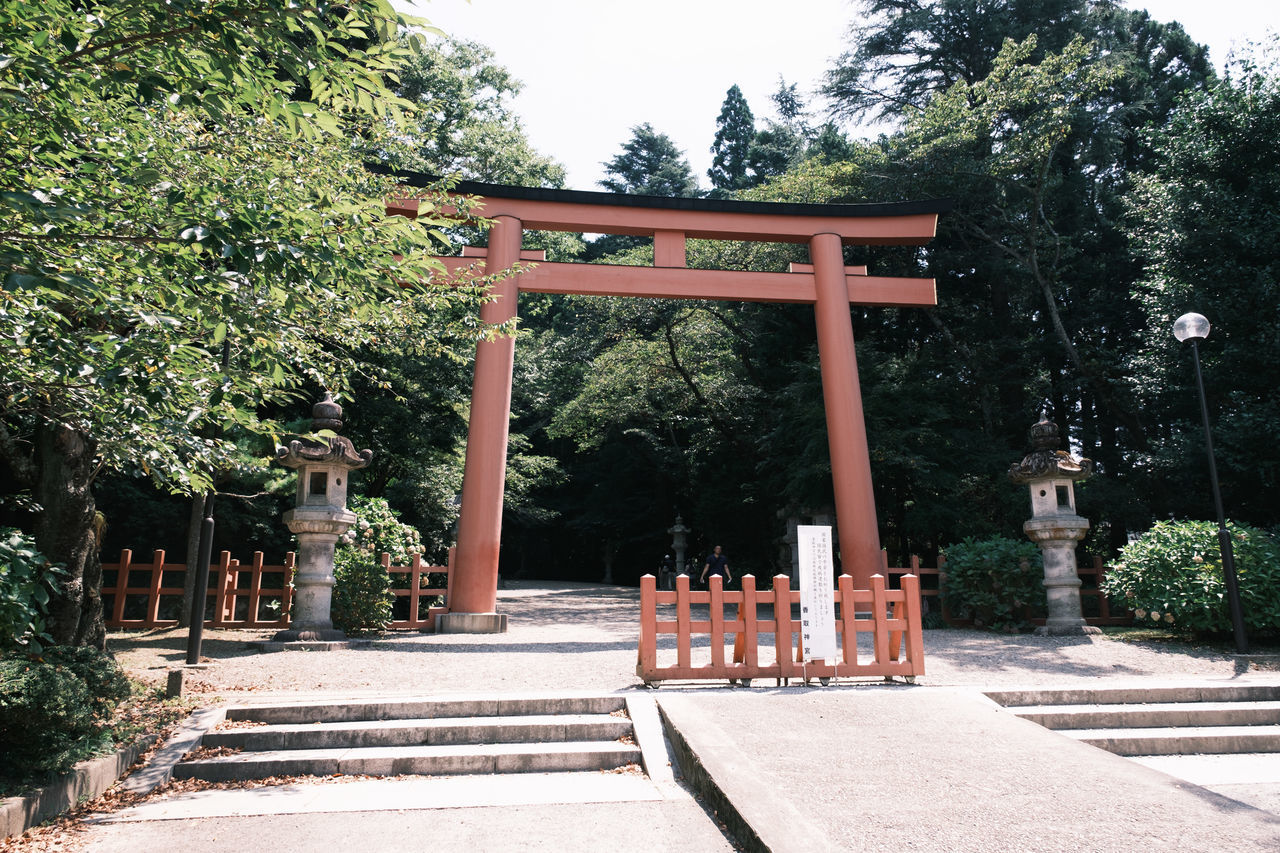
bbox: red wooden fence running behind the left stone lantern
[102,548,453,631]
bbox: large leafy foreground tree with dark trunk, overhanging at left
[0,0,488,646]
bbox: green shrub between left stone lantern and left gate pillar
[330,497,422,635]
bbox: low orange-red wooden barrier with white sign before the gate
[636,575,924,685]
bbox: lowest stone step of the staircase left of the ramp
[173,740,640,781]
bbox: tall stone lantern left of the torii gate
[273,392,374,642]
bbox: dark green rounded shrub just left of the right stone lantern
[942,537,1044,633]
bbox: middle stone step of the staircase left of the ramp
[202,713,631,752]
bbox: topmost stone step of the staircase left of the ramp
[227,695,626,725]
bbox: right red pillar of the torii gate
[809,233,881,573]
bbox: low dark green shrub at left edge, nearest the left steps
[0,647,129,777]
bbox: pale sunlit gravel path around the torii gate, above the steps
[109,581,1239,697]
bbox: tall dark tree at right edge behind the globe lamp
[1128,48,1280,525]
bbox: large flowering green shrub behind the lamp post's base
[1103,521,1280,634]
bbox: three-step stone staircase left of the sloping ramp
[173,695,641,781]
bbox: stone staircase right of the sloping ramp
[987,684,1280,757]
